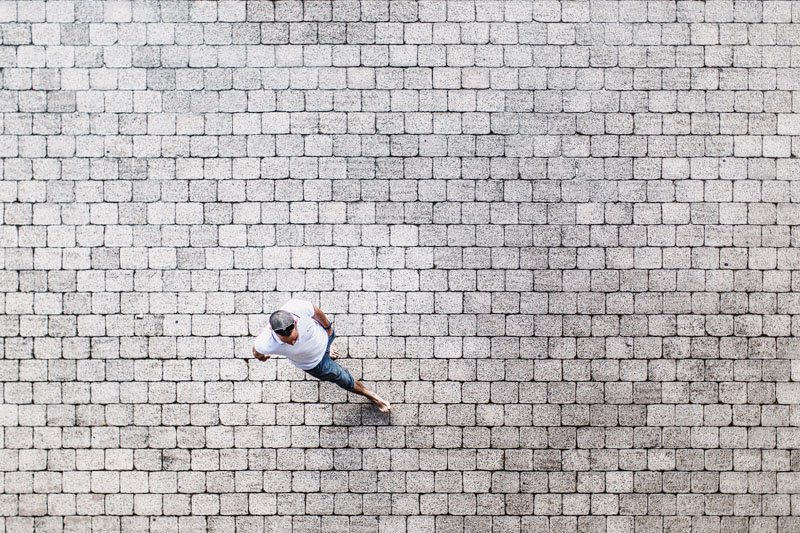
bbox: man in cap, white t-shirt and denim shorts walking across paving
[248,298,392,413]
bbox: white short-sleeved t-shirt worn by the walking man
[253,298,328,370]
